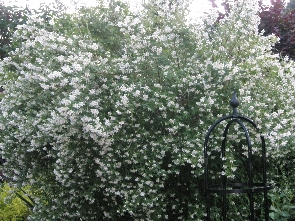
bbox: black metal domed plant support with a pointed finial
[204,93,272,221]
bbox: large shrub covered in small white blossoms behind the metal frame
[0,0,295,220]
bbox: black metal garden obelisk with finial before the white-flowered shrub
[204,93,272,221]
